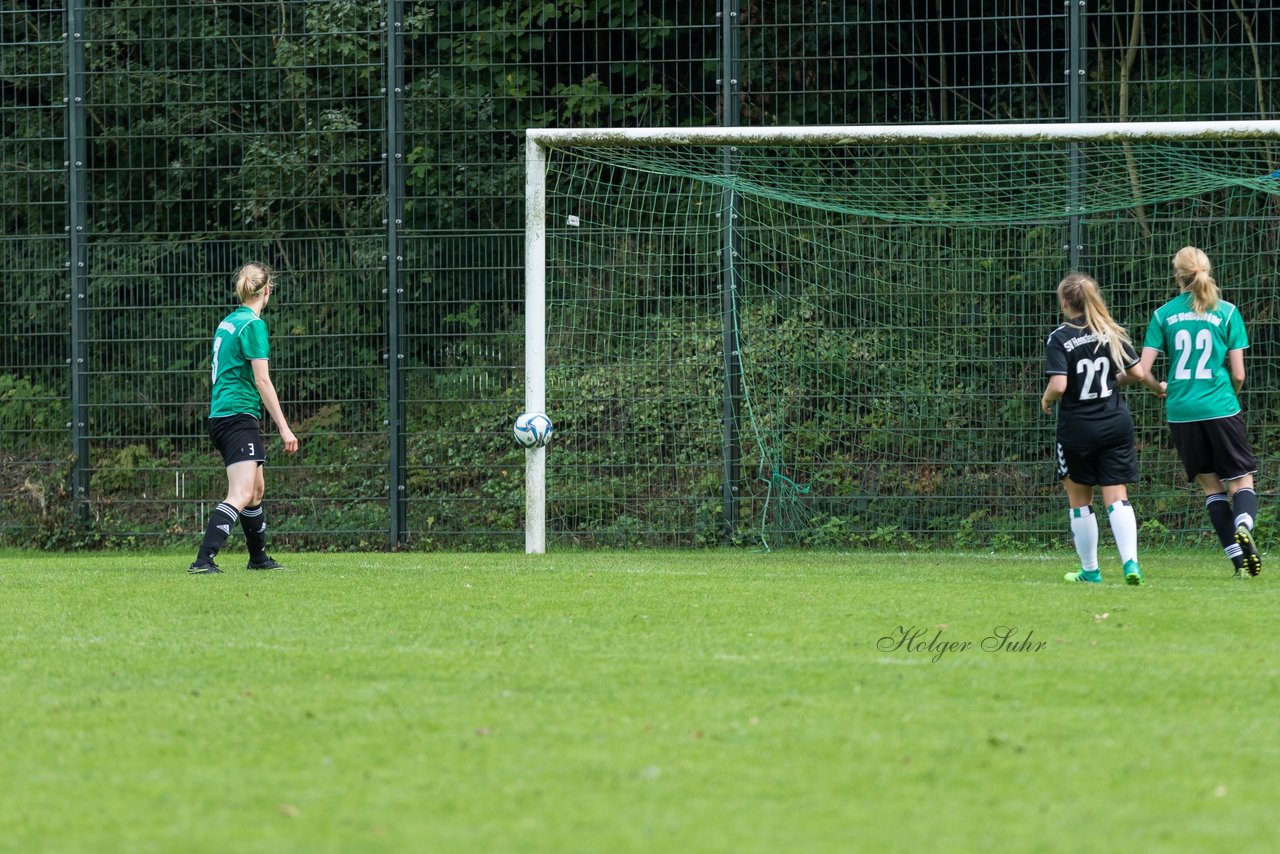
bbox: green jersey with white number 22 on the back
[1142,293,1249,421]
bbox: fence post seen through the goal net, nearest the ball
[718,0,742,536]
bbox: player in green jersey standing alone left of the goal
[187,264,298,575]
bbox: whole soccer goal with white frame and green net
[526,122,1280,552]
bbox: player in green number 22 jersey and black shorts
[1142,246,1262,577]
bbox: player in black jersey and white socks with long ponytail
[1041,273,1143,584]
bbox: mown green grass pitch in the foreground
[0,549,1280,851]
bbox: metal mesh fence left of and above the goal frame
[0,0,1280,548]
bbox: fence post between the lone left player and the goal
[383,0,407,548]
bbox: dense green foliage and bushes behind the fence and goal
[0,0,1280,548]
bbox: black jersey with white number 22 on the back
[1044,318,1138,448]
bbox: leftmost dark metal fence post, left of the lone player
[63,0,91,522]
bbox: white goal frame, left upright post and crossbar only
[525,119,1280,554]
